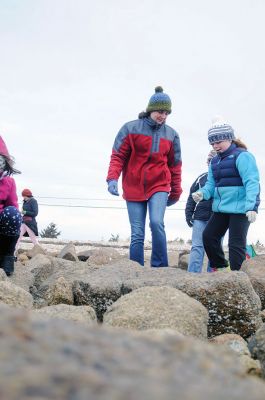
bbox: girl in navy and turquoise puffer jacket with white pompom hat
[192,117,260,271]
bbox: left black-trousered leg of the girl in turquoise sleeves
[202,213,230,268]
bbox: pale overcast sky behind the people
[0,0,265,244]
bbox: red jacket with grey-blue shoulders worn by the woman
[107,118,182,201]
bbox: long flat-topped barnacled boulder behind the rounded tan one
[29,259,262,338]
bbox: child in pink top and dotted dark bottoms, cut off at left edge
[0,136,22,276]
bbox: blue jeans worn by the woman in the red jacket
[127,192,168,267]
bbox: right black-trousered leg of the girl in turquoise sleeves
[228,214,250,271]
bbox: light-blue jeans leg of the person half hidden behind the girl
[188,219,207,272]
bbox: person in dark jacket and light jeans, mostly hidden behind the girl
[185,150,216,272]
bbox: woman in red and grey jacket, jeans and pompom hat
[107,86,182,267]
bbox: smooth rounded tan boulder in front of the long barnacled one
[104,286,208,339]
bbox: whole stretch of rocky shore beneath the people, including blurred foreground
[0,239,265,400]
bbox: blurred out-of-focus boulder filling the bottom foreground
[0,306,265,400]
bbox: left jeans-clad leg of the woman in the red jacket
[127,201,147,265]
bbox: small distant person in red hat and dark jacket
[16,189,39,249]
